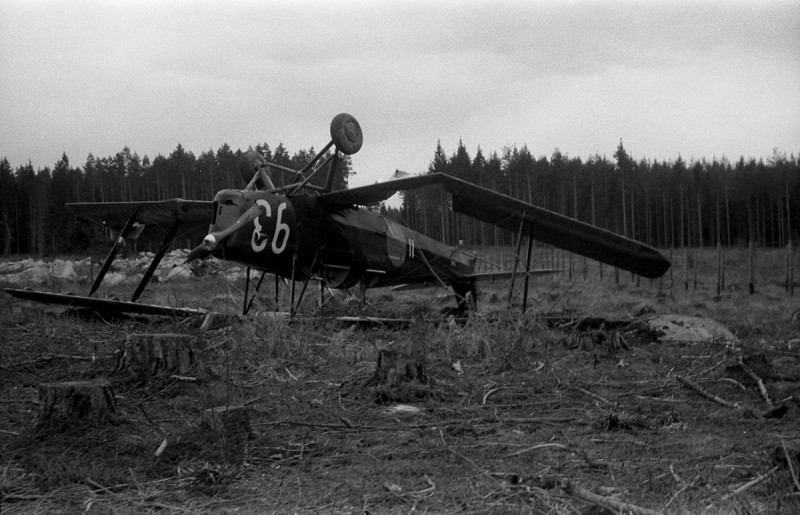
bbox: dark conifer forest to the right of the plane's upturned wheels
[385,141,800,254]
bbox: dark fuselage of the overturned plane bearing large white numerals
[209,190,475,288]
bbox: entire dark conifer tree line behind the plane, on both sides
[0,141,800,256]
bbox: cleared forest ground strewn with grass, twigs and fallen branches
[0,272,800,514]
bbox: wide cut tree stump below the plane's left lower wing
[115,333,201,380]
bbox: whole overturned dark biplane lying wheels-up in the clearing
[6,113,670,315]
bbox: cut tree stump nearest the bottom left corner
[36,379,118,433]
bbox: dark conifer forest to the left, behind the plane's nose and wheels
[0,143,352,256]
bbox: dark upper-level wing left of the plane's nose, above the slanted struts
[67,199,214,229]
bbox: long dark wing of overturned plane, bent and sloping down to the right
[319,173,670,278]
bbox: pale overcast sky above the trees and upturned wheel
[0,0,800,185]
